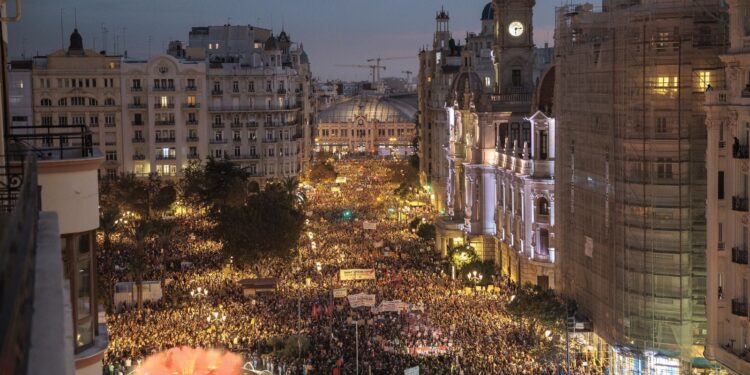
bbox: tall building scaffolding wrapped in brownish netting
[555,0,727,373]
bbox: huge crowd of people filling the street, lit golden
[100,160,600,375]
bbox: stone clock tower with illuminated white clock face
[492,0,535,94]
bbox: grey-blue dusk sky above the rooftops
[9,0,560,80]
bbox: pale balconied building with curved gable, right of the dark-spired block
[121,55,208,176]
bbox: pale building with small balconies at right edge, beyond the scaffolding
[705,0,750,374]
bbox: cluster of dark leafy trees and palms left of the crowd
[99,159,306,309]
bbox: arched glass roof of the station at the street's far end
[318,96,417,123]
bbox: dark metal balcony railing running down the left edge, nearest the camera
[0,153,41,374]
